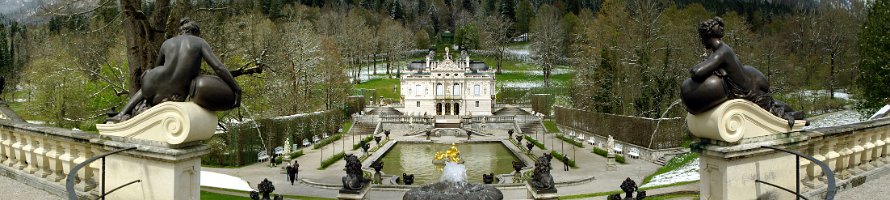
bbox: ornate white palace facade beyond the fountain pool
[400,48,496,116]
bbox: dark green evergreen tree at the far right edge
[856,0,890,113]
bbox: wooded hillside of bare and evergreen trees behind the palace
[0,0,890,129]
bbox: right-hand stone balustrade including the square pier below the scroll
[693,115,890,199]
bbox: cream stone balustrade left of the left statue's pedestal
[0,120,105,199]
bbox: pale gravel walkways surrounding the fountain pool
[203,123,672,199]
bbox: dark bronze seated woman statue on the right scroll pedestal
[680,17,803,127]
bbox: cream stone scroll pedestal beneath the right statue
[686,99,805,200]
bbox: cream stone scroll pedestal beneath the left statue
[96,102,217,200]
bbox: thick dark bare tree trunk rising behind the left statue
[119,0,171,94]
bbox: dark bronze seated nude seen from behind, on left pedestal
[106,18,241,122]
